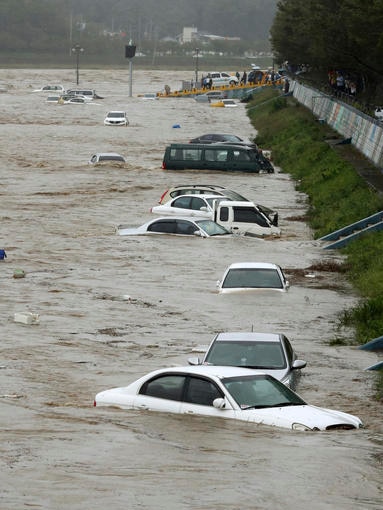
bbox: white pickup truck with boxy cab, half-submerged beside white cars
[212,200,281,237]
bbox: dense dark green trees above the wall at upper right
[270,0,383,97]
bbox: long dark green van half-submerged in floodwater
[162,143,274,173]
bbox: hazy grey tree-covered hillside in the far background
[0,0,277,54]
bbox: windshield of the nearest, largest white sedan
[222,375,306,409]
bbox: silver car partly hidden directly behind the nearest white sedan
[188,331,306,389]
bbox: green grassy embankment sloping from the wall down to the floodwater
[248,89,383,399]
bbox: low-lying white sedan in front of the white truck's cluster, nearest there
[117,216,231,237]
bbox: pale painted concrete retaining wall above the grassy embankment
[290,81,383,168]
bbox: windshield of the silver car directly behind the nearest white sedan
[204,340,286,370]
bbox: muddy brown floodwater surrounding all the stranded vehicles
[0,69,383,510]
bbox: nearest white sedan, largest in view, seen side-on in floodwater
[94,365,363,431]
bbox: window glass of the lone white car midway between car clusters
[222,268,283,289]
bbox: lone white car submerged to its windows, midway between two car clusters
[217,262,289,293]
